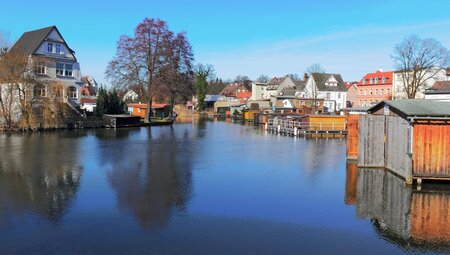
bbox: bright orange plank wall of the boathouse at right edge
[413,124,450,178]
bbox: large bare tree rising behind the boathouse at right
[391,35,450,99]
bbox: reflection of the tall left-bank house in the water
[0,132,85,223]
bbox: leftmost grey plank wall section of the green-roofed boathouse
[358,115,385,168]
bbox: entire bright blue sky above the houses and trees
[0,0,450,84]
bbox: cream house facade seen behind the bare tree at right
[392,68,449,99]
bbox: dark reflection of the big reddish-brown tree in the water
[102,128,197,230]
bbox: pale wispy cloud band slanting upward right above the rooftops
[198,20,450,80]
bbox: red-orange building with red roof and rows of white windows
[356,70,394,107]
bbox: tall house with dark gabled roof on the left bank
[10,26,83,106]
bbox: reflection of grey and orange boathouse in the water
[346,164,450,252]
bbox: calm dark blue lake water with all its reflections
[0,121,450,254]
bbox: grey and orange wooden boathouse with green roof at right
[358,99,450,183]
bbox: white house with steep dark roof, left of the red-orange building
[302,73,347,112]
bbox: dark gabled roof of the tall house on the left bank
[11,26,75,55]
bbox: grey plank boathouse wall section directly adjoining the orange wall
[385,116,412,183]
